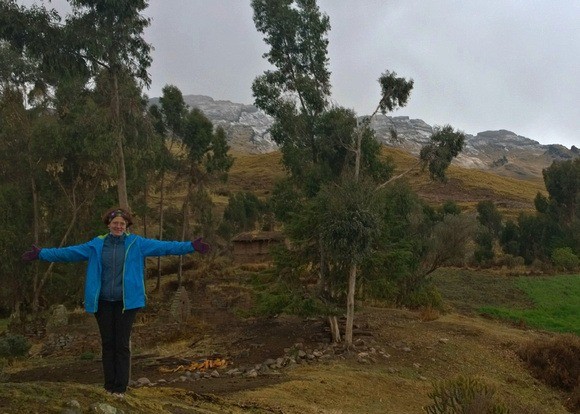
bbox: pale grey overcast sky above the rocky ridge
[23,0,580,148]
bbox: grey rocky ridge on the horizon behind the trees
[150,95,580,183]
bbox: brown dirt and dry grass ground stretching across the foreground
[0,276,566,414]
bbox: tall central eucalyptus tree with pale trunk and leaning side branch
[252,0,464,345]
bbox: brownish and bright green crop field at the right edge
[433,269,580,335]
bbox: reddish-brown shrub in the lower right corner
[518,334,580,409]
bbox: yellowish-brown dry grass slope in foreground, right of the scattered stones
[227,311,567,414]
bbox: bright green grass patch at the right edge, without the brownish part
[481,275,580,335]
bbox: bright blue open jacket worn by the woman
[39,233,194,313]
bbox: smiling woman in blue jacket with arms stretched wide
[22,208,209,398]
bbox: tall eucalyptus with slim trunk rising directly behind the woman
[0,0,151,207]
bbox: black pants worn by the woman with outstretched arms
[95,300,137,392]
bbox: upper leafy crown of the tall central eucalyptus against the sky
[252,0,330,120]
